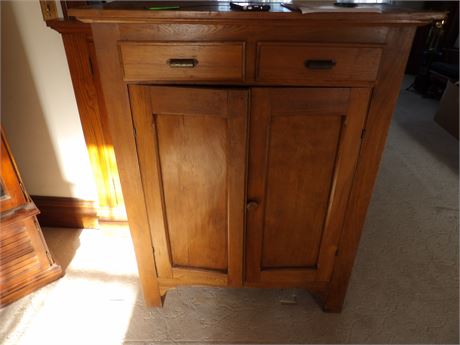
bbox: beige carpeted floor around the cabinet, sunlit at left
[0,76,459,345]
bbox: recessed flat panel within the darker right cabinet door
[262,115,342,269]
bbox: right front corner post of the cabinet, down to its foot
[319,27,415,312]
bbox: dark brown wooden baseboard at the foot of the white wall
[31,195,99,229]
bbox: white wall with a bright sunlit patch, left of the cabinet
[0,0,97,200]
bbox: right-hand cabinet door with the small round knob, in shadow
[246,88,370,286]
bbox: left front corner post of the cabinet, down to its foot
[93,24,162,306]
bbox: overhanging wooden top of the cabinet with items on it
[69,1,445,25]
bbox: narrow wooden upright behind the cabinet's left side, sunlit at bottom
[62,33,126,220]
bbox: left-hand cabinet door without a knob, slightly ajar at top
[129,86,248,286]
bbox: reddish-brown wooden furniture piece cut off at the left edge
[0,127,63,306]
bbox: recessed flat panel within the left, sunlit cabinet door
[155,114,228,271]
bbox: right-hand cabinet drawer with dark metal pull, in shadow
[257,43,382,85]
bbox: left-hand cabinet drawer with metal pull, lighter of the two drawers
[120,42,244,81]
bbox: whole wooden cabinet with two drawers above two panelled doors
[66,2,443,311]
